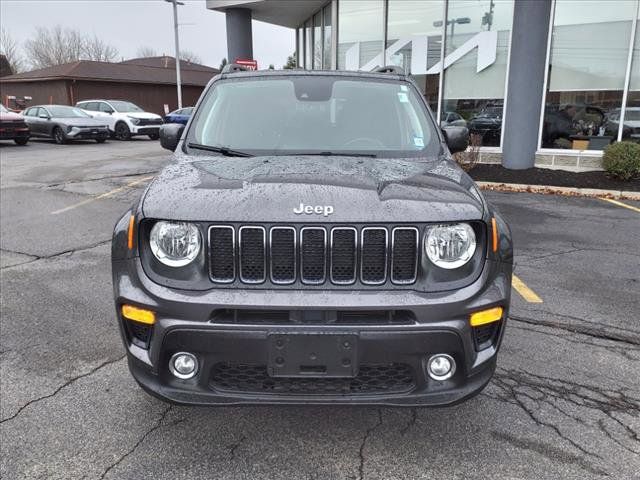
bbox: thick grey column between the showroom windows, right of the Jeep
[502,0,551,170]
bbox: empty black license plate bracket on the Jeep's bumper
[267,333,358,378]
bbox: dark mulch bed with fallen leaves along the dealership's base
[468,164,640,192]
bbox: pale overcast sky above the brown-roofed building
[0,0,295,68]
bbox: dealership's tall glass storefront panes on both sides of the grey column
[298,0,640,150]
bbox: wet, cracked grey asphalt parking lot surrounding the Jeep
[0,139,640,480]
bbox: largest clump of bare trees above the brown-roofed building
[25,25,118,68]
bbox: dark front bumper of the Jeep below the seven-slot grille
[113,253,512,406]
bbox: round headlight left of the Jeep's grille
[149,221,201,267]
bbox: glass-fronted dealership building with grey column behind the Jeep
[207,0,640,170]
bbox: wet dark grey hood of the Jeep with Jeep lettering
[143,156,483,223]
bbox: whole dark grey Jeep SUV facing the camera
[112,66,513,405]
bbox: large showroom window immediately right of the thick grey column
[542,0,636,150]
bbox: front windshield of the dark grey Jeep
[186,76,440,157]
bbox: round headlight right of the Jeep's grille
[424,223,476,270]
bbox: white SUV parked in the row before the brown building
[76,100,163,140]
